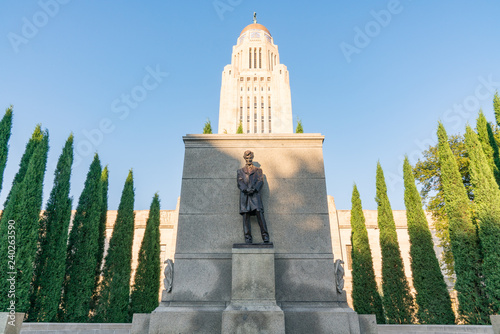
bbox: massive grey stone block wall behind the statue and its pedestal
[150,134,359,333]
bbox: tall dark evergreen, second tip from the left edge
[0,127,49,312]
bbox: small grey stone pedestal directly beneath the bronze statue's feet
[222,244,285,334]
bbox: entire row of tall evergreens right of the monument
[351,90,500,324]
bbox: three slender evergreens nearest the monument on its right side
[351,158,455,324]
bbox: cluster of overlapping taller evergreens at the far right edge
[438,117,500,324]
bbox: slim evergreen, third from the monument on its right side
[403,157,455,324]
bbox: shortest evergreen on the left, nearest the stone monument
[130,194,161,315]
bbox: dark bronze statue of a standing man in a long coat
[237,151,269,244]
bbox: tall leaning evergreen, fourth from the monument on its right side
[437,123,488,324]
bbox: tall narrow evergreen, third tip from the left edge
[29,135,73,322]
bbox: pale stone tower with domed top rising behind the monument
[218,15,293,134]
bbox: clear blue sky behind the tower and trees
[0,0,500,210]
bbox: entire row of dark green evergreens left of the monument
[0,107,161,322]
